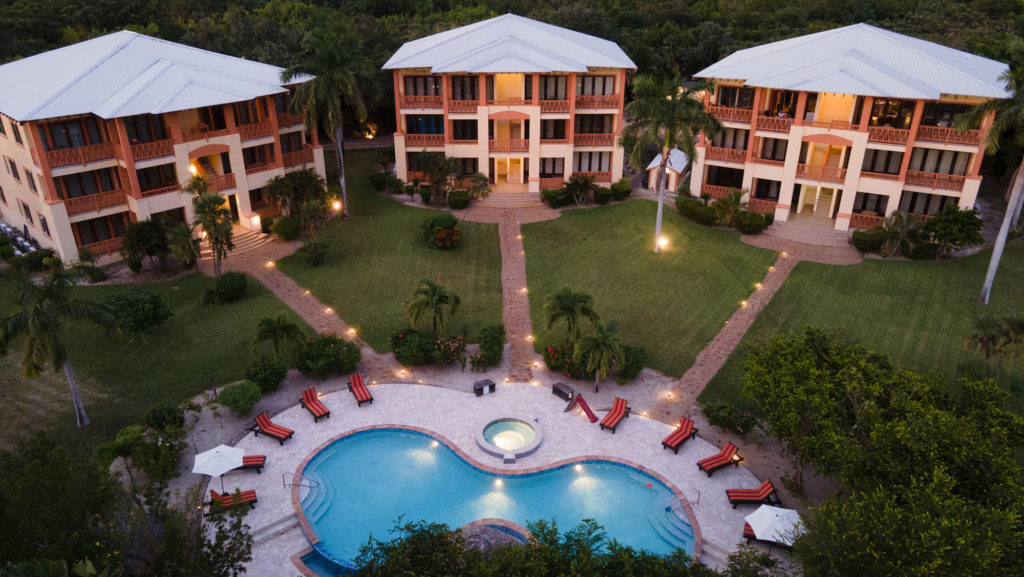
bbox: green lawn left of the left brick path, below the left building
[0,275,306,451]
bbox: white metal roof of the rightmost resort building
[694,24,1010,100]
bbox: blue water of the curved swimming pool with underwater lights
[301,428,693,563]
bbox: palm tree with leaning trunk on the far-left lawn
[0,263,118,426]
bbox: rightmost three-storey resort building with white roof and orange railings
[690,24,1009,231]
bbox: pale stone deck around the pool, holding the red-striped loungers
[222,383,760,577]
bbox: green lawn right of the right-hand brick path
[699,244,1024,411]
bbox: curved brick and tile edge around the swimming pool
[292,424,703,561]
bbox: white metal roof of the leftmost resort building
[0,31,308,122]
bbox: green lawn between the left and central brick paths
[279,150,502,352]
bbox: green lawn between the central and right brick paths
[522,200,774,376]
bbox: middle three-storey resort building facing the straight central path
[384,14,636,194]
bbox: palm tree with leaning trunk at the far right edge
[955,67,1024,304]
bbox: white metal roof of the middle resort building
[384,14,636,73]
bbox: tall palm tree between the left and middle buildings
[281,30,376,217]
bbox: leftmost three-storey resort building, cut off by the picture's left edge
[0,31,324,261]
